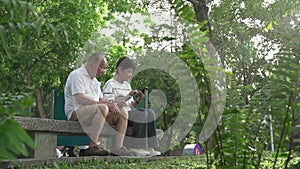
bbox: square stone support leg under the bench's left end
[33,132,57,158]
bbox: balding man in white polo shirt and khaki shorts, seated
[64,53,136,156]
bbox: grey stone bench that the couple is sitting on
[14,116,114,158]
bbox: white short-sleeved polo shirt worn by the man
[64,65,103,119]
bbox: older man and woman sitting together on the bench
[64,52,161,156]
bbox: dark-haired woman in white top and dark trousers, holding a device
[103,57,161,156]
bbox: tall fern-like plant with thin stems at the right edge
[265,49,300,168]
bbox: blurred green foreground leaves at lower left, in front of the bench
[0,94,34,162]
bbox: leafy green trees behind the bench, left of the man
[0,0,107,117]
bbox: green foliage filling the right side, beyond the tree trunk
[206,1,299,168]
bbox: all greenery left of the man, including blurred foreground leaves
[0,0,106,160]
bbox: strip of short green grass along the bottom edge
[15,154,300,169]
